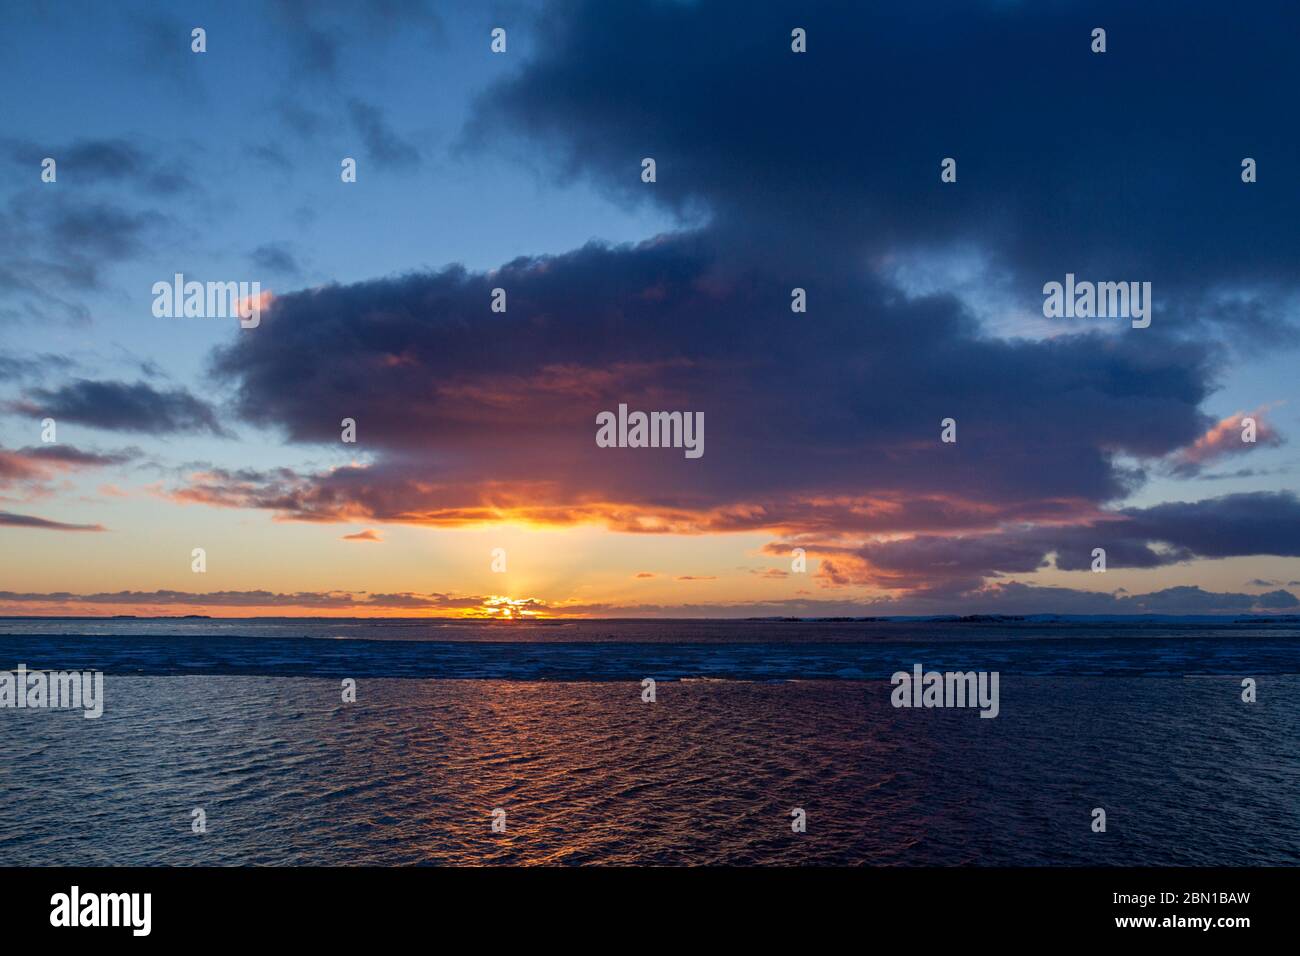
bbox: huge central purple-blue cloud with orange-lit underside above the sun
[200,233,1210,533]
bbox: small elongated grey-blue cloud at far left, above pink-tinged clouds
[10,378,230,437]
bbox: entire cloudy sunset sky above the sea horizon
[0,0,1300,618]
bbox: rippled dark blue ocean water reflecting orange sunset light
[0,620,1300,866]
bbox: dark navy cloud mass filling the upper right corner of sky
[465,0,1300,343]
